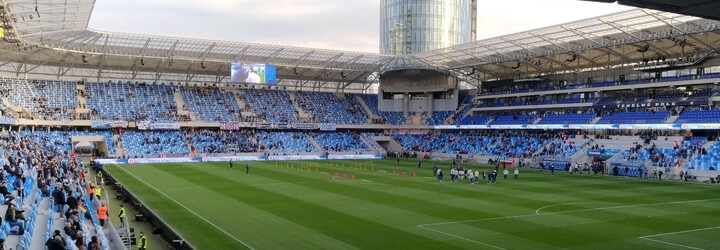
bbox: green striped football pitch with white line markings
[106,160,720,249]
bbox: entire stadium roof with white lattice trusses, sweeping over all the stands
[0,0,720,89]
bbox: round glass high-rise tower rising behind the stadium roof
[380,0,477,55]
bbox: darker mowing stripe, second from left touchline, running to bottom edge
[163,165,456,249]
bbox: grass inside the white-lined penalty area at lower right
[419,198,717,249]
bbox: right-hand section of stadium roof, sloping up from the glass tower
[418,9,720,79]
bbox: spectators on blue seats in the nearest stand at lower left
[0,130,110,249]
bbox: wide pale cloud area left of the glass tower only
[91,0,379,52]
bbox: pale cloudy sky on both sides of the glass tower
[90,0,631,53]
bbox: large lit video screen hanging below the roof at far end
[230,62,277,84]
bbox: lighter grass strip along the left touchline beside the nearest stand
[126,164,362,249]
